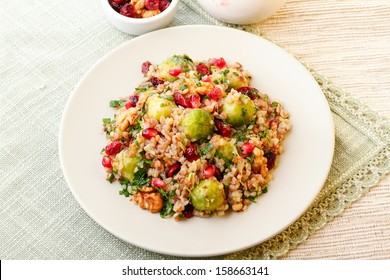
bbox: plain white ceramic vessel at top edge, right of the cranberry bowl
[197,0,286,24]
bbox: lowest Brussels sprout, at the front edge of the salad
[190,179,226,211]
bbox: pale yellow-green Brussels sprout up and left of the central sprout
[146,94,177,121]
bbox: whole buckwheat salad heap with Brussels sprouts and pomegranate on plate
[101,55,291,221]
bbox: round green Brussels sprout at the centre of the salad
[181,109,214,142]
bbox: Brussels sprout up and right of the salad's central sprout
[222,92,256,127]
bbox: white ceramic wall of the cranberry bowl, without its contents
[101,0,179,35]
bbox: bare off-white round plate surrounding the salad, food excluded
[59,25,334,256]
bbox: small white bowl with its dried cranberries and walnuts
[102,0,179,35]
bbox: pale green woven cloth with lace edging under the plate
[0,0,390,259]
